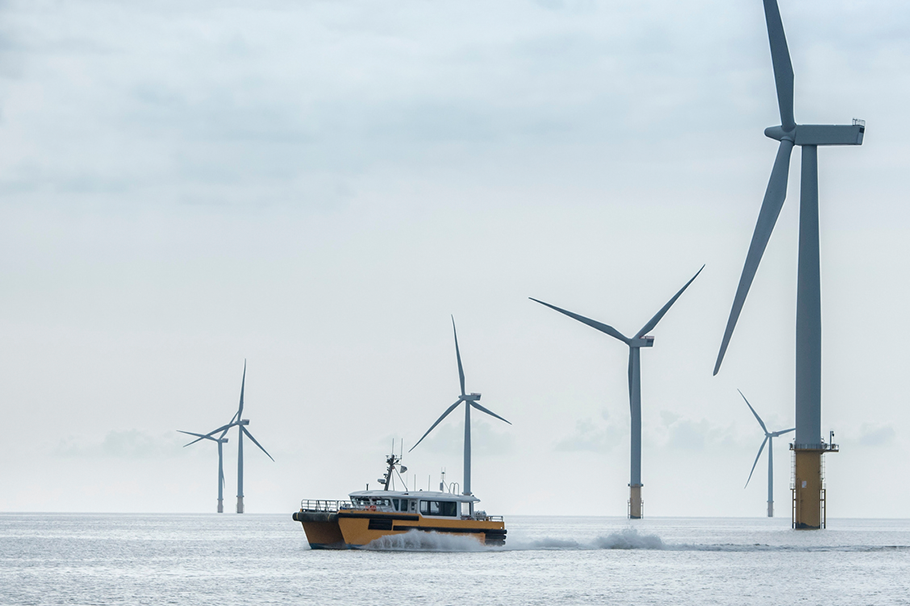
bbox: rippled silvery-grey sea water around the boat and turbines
[0,513,910,606]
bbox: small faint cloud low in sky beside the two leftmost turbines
[54,429,183,459]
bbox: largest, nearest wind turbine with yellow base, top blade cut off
[714,0,866,529]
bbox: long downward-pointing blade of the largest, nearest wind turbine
[714,139,793,375]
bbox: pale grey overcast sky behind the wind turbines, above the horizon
[0,0,910,517]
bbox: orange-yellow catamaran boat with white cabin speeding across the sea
[293,453,506,549]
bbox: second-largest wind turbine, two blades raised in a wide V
[529,265,705,520]
